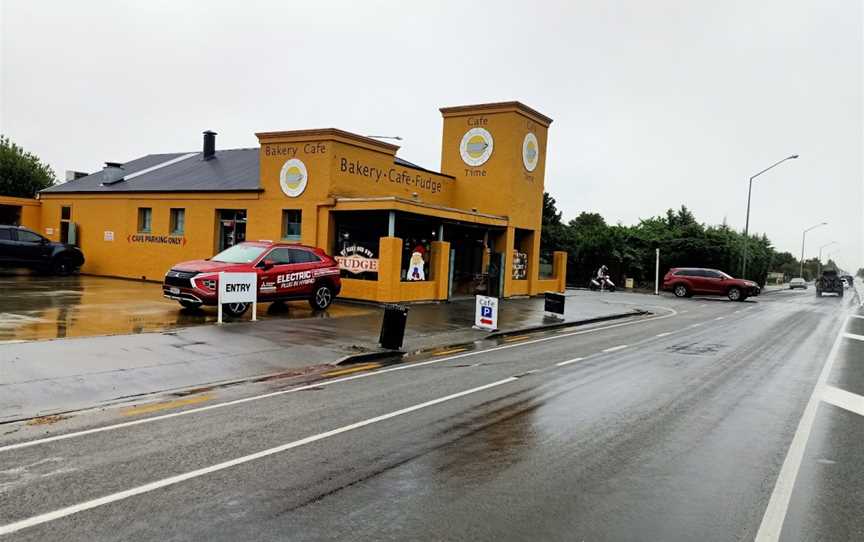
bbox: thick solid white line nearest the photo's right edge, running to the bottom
[754,318,849,542]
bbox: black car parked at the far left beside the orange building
[0,225,84,275]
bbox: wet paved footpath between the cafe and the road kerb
[0,291,648,422]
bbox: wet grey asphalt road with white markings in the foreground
[0,291,864,541]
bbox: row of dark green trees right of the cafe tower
[540,194,828,288]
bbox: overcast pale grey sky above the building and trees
[0,0,864,268]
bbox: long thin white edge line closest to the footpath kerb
[0,307,678,452]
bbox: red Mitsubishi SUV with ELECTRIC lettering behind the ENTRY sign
[162,241,342,316]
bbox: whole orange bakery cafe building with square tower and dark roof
[11,102,566,302]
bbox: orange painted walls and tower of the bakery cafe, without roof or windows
[37,103,563,301]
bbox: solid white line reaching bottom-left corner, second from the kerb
[0,376,518,535]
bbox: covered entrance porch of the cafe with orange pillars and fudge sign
[319,197,566,302]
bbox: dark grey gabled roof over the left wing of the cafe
[41,149,261,194]
